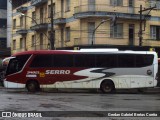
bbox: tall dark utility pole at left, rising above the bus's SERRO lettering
[50,0,55,50]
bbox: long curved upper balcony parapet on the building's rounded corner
[74,4,143,19]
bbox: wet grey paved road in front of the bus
[0,89,160,120]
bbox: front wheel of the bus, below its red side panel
[26,81,39,92]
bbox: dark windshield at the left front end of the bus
[6,55,30,75]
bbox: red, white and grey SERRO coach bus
[4,49,158,93]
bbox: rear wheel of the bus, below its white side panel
[100,81,115,93]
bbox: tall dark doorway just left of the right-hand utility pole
[129,24,135,46]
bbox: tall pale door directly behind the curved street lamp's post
[88,22,95,44]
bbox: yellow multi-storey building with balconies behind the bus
[11,0,160,53]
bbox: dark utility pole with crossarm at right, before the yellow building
[139,5,156,46]
